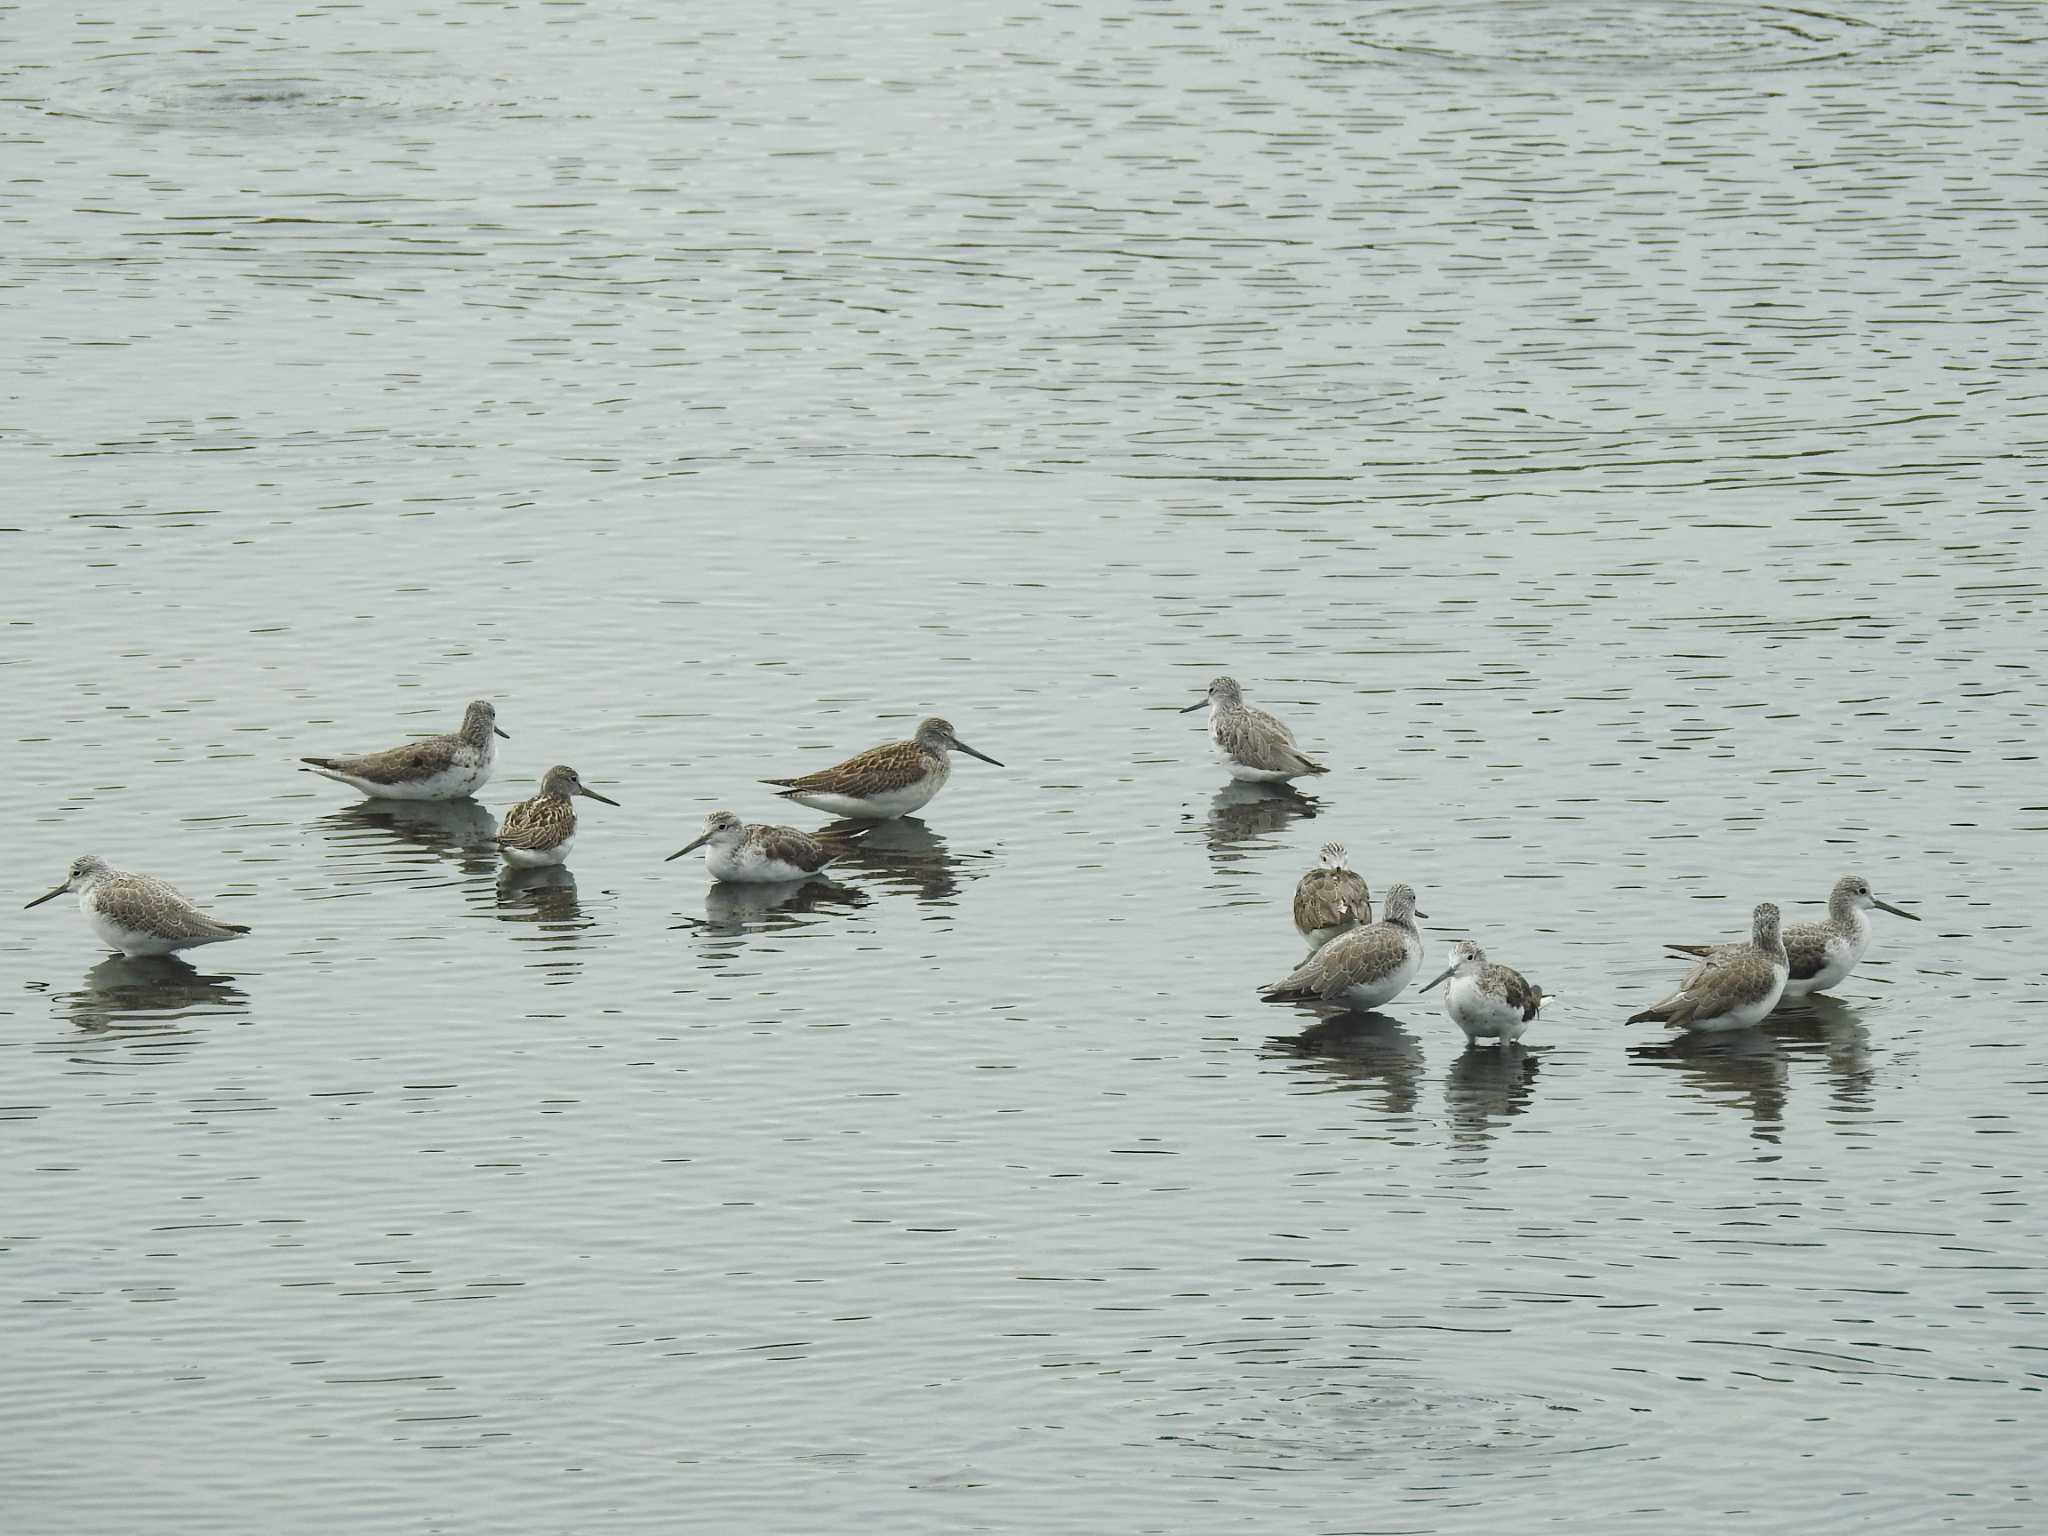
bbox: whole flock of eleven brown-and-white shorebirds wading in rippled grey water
[29,678,1919,1042]
